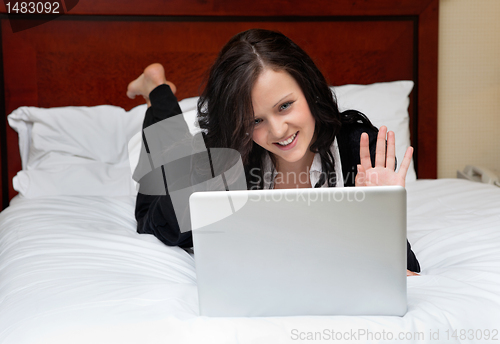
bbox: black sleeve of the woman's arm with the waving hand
[337,123,420,272]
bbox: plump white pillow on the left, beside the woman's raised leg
[8,105,146,198]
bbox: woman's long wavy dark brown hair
[198,29,374,189]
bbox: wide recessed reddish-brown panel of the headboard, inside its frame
[4,20,413,113]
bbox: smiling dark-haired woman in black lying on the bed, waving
[127,29,420,274]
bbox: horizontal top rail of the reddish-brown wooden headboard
[0,0,433,16]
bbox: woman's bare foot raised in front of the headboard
[127,63,177,106]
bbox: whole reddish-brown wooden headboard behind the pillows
[0,0,439,209]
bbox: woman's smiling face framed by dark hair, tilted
[252,68,315,171]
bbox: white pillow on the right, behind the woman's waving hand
[331,81,417,182]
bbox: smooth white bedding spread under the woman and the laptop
[0,179,500,344]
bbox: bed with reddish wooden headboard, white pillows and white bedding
[0,0,500,344]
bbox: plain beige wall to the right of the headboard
[438,0,500,178]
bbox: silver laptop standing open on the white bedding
[190,186,407,317]
